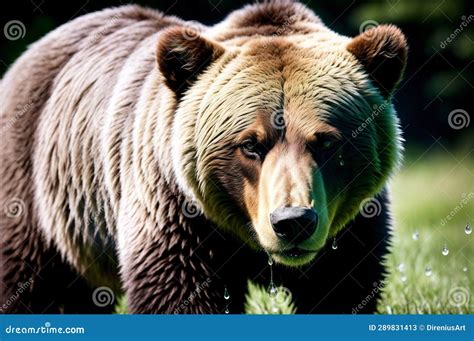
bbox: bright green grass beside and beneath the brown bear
[116,149,474,314]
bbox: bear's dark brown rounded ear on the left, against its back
[156,27,224,96]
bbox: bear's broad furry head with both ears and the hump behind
[157,4,407,266]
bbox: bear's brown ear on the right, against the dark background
[347,25,408,97]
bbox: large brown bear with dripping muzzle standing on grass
[0,1,407,313]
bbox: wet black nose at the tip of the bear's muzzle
[270,207,318,244]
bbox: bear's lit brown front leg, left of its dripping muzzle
[117,193,231,314]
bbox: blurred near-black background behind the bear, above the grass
[0,0,474,151]
